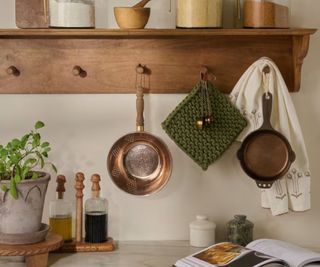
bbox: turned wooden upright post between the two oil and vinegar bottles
[74,172,85,242]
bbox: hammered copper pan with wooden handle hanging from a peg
[107,87,172,196]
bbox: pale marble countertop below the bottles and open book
[0,241,200,267]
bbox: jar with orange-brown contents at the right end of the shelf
[243,0,290,28]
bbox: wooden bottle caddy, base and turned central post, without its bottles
[56,172,115,253]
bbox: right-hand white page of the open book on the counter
[247,239,320,267]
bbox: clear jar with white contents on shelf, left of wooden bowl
[49,0,95,28]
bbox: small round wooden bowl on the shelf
[114,7,150,29]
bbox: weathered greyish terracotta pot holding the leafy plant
[0,173,50,234]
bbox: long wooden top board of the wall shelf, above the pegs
[0,28,317,38]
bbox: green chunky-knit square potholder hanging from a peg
[162,82,247,170]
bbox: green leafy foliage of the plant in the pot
[0,121,57,199]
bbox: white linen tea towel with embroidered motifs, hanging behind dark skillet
[230,57,311,216]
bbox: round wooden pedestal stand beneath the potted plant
[0,233,63,267]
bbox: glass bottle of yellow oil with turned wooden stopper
[49,175,72,242]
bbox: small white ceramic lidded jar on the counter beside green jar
[189,215,216,247]
